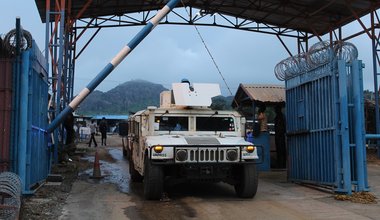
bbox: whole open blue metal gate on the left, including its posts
[12,41,51,194]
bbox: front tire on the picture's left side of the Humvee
[144,155,164,200]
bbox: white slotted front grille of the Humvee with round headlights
[175,146,240,163]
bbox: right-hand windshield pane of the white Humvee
[196,116,235,131]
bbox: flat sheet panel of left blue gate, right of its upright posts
[25,41,51,190]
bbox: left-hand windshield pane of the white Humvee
[154,116,189,131]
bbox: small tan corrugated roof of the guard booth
[237,84,285,102]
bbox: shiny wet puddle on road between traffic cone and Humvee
[79,149,131,194]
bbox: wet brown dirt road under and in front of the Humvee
[59,142,380,219]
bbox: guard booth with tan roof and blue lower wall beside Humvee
[232,84,285,171]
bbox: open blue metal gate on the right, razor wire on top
[283,42,368,194]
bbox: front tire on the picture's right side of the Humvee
[235,164,258,198]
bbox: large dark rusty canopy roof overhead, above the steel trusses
[35,0,380,35]
